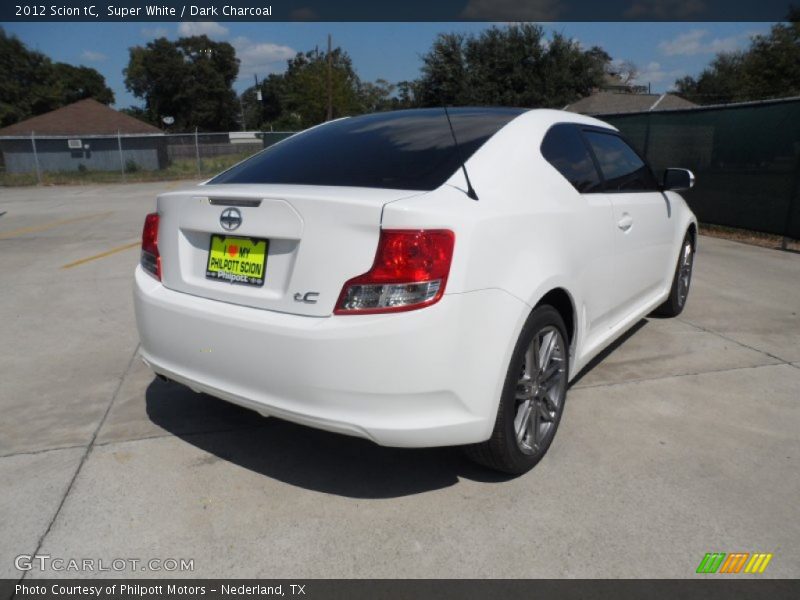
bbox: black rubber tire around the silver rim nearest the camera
[464,305,569,475]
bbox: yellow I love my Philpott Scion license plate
[206,234,269,287]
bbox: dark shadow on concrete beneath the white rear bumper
[146,379,511,498]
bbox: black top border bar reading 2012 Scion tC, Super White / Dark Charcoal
[0,0,800,22]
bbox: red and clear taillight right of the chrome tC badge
[334,229,455,315]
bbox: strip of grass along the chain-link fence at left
[0,152,252,187]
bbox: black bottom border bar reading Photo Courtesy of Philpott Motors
[0,575,800,600]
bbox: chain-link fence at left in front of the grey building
[0,131,294,185]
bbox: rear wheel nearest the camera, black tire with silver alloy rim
[465,306,569,475]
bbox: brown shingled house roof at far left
[0,98,163,137]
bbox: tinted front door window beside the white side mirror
[584,131,658,192]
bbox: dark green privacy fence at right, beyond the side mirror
[600,98,800,239]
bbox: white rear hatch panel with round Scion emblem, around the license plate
[158,184,423,317]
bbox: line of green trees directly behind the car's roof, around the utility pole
[243,24,611,130]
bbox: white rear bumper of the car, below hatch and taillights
[134,267,529,447]
